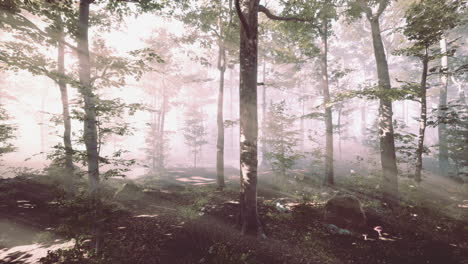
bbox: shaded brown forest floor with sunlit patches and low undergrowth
[0,169,468,264]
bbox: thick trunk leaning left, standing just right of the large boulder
[369,17,398,202]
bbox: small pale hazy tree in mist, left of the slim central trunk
[183,105,208,168]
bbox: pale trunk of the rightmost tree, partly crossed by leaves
[437,37,449,177]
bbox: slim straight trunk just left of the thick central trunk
[216,14,226,190]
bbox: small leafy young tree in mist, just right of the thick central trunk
[262,100,301,182]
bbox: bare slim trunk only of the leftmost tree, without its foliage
[57,23,74,193]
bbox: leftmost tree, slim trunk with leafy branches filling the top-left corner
[0,1,76,190]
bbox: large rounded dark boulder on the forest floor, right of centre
[324,193,366,230]
